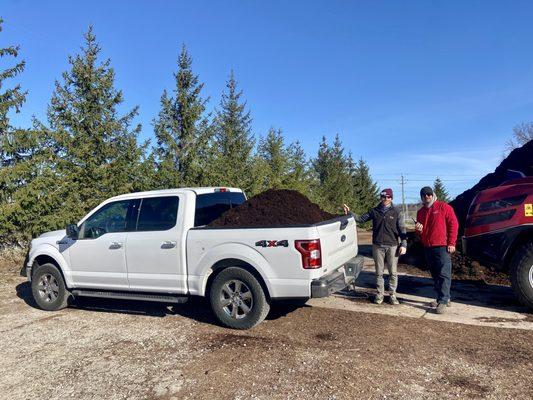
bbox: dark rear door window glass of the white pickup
[137,196,179,231]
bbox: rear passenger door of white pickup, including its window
[126,195,187,293]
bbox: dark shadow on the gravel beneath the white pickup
[16,282,305,325]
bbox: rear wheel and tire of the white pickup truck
[209,267,270,329]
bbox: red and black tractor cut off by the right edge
[463,177,533,308]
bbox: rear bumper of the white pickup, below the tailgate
[311,256,364,297]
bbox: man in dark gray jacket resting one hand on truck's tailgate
[343,189,407,305]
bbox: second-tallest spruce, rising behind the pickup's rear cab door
[154,46,212,188]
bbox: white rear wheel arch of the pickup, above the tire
[198,243,274,297]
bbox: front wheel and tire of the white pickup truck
[31,263,71,311]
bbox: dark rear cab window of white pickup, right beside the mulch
[194,192,246,226]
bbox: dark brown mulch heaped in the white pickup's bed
[207,189,337,227]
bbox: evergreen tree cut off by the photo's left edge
[0,19,62,248]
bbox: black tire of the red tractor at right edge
[510,242,533,309]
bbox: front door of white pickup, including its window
[67,200,135,289]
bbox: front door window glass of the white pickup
[79,200,132,239]
